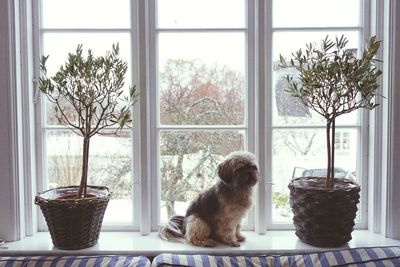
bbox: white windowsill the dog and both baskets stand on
[0,230,400,257]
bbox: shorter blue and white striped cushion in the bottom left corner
[0,255,151,267]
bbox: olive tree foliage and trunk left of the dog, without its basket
[39,44,138,198]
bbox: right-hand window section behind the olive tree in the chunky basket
[267,0,366,228]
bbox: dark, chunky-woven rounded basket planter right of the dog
[289,177,360,247]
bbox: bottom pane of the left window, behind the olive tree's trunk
[45,130,133,224]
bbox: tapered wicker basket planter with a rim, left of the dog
[35,186,111,250]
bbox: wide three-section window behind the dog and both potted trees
[35,0,369,230]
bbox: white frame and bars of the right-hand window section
[259,0,370,230]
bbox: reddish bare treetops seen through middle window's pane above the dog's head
[160,59,244,125]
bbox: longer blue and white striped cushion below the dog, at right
[152,247,400,267]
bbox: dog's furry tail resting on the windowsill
[158,215,185,243]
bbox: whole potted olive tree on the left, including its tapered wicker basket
[35,44,137,249]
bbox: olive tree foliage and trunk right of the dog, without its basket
[280,35,382,188]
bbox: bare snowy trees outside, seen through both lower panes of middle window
[160,60,244,220]
